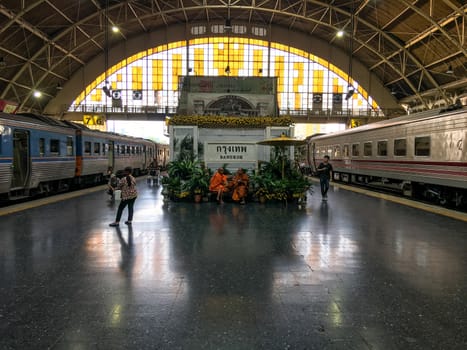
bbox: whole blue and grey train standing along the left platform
[0,113,169,202]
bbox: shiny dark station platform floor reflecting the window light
[0,181,467,350]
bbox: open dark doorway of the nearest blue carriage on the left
[11,129,31,188]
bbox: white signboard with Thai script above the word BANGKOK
[205,142,257,163]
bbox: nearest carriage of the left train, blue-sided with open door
[0,113,75,199]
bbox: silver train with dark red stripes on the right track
[307,103,467,210]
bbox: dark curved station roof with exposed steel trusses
[0,0,467,112]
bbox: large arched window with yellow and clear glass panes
[70,37,379,114]
